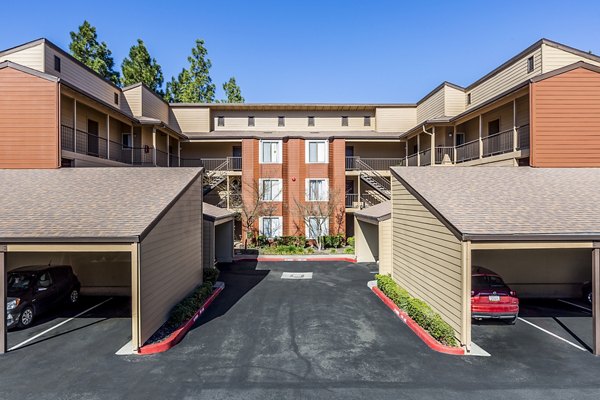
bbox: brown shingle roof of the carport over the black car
[0,168,202,243]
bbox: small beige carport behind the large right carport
[354,201,392,274]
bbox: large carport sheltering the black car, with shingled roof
[0,168,202,352]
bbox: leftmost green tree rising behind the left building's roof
[69,21,119,85]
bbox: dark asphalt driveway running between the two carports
[0,262,600,399]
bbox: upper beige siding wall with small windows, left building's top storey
[45,46,129,112]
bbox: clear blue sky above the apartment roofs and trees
[0,0,600,103]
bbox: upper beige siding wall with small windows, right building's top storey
[465,47,542,109]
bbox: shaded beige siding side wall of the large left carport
[139,179,202,343]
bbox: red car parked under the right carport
[471,267,519,324]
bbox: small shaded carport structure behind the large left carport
[202,203,235,268]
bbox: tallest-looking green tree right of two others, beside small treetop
[166,39,216,103]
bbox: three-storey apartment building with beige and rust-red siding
[0,39,600,237]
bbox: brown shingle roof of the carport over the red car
[392,167,600,240]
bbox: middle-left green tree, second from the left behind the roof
[121,39,164,96]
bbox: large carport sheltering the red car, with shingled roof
[392,167,600,355]
